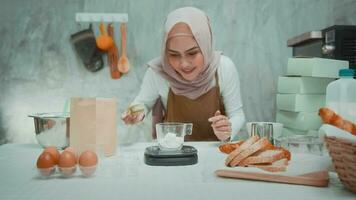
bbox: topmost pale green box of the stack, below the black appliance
[287,58,349,78]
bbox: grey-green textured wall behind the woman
[0,0,356,143]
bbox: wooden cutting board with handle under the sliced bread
[215,170,329,187]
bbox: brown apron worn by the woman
[164,73,225,141]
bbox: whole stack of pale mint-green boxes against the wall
[276,58,349,135]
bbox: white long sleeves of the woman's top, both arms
[131,55,245,139]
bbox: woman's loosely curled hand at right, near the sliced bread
[208,110,231,141]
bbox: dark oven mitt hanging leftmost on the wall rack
[70,24,104,72]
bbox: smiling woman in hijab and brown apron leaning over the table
[122,7,245,141]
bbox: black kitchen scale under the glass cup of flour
[144,145,198,166]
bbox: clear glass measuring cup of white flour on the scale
[156,122,193,151]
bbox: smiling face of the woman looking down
[166,23,204,81]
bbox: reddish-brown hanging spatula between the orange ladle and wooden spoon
[108,24,121,79]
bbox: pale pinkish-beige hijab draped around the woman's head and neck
[148,7,221,99]
